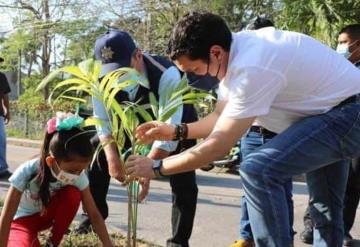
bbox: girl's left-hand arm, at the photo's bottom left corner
[0,186,22,247]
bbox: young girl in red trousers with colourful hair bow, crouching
[0,113,113,247]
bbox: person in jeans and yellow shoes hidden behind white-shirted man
[229,17,295,247]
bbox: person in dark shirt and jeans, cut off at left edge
[0,57,11,179]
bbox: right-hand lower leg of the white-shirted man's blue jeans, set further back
[306,159,351,246]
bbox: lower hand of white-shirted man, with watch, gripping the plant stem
[125,155,155,178]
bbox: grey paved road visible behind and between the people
[0,145,360,247]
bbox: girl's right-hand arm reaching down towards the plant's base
[81,186,113,247]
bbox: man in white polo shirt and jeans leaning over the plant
[127,12,360,247]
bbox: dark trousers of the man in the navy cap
[80,137,198,247]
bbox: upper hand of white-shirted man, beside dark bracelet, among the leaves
[135,121,175,144]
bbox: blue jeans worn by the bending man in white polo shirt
[240,103,360,247]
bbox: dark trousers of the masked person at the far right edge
[304,158,360,236]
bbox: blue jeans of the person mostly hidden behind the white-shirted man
[240,130,295,240]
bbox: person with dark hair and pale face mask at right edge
[300,24,360,246]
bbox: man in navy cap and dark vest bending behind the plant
[76,31,198,247]
